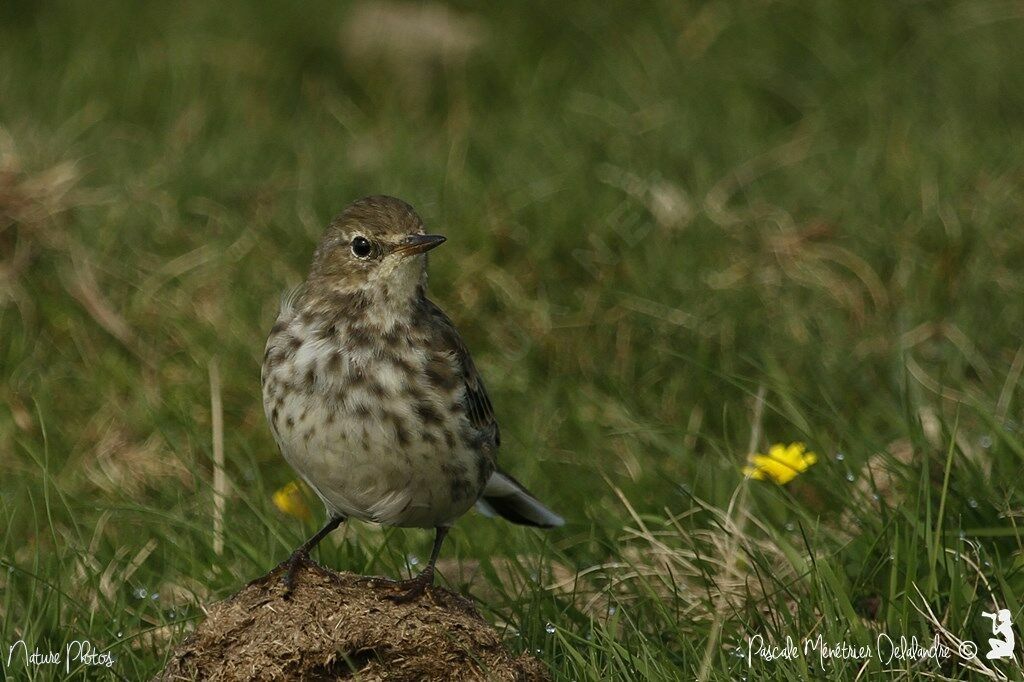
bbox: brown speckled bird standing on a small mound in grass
[261,196,564,601]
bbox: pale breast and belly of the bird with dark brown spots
[263,313,489,525]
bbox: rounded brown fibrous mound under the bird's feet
[156,566,550,682]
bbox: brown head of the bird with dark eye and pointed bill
[309,197,444,299]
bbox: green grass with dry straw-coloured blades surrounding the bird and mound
[0,0,1024,680]
